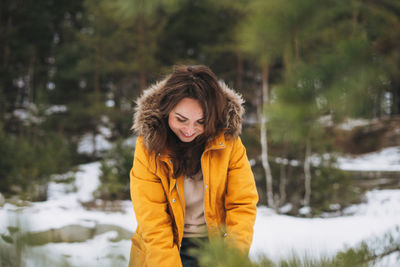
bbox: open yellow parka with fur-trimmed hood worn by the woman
[130,76,258,267]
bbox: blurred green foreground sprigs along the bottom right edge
[193,228,400,267]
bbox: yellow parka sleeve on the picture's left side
[130,137,182,267]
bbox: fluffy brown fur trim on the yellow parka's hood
[131,76,244,147]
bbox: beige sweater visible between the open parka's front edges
[183,172,207,237]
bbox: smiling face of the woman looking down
[168,97,204,142]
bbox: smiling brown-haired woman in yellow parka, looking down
[130,66,258,267]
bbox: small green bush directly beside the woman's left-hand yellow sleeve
[95,140,133,200]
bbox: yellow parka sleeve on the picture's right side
[225,137,258,253]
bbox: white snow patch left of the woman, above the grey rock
[0,162,136,232]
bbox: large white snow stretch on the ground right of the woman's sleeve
[250,190,400,259]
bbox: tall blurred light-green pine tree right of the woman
[241,0,387,214]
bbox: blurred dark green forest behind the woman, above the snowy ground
[0,0,400,216]
